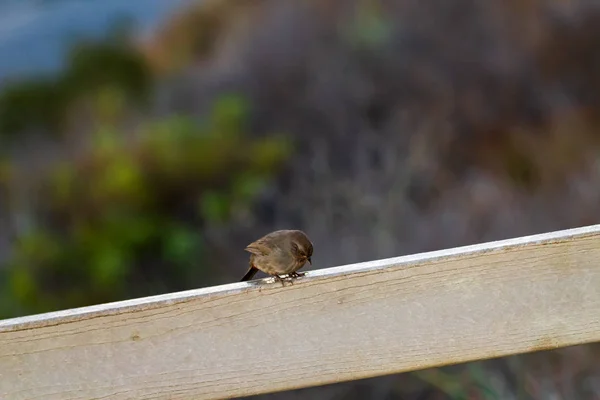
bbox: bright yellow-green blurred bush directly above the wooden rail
[0,92,290,318]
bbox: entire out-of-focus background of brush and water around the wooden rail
[0,0,600,400]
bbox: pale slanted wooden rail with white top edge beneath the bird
[0,225,600,400]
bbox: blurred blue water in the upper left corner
[0,0,191,84]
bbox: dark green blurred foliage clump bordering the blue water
[0,32,153,139]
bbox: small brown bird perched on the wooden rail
[242,230,313,284]
